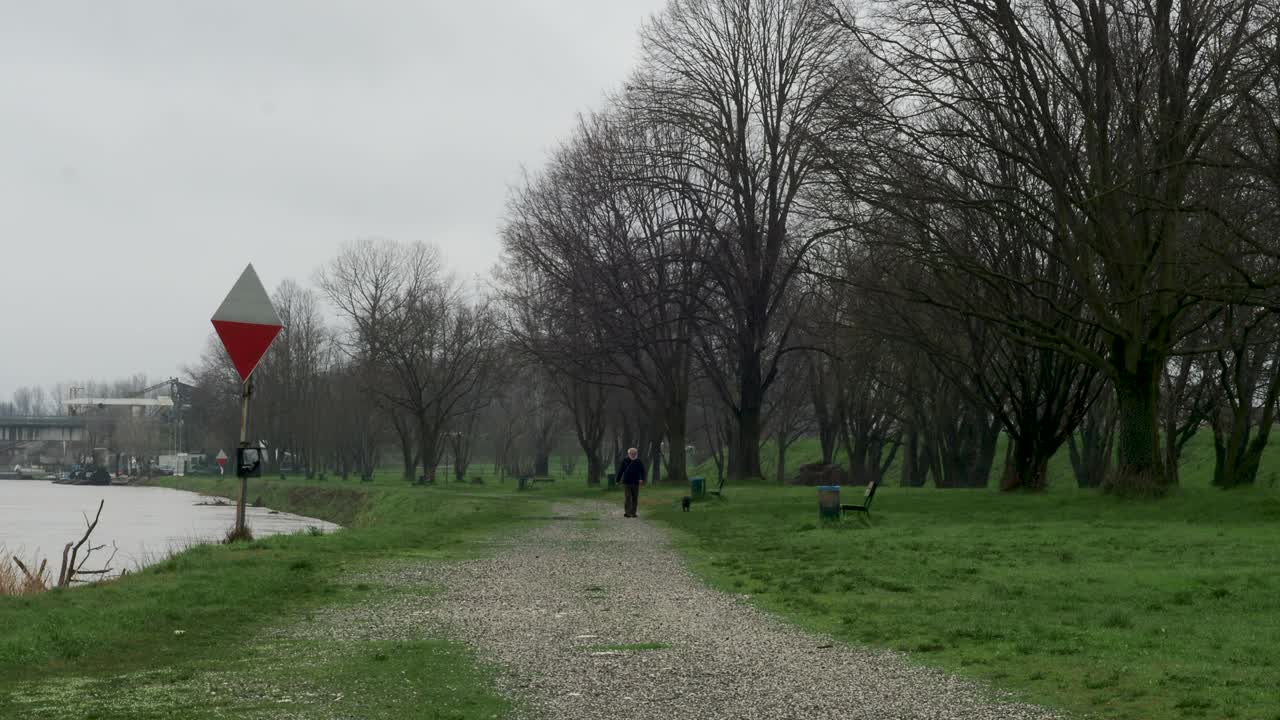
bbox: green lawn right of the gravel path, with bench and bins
[609,427,1280,720]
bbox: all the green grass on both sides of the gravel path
[0,427,1280,720]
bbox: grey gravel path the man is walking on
[412,503,1055,720]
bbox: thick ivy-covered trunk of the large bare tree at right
[1103,356,1169,497]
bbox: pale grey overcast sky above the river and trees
[0,0,664,400]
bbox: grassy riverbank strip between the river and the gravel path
[0,478,545,719]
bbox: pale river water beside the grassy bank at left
[0,480,338,575]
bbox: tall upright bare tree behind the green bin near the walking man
[625,0,851,478]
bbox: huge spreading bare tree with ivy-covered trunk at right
[838,0,1277,493]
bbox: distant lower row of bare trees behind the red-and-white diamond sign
[189,240,581,482]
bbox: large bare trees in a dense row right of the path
[499,0,1280,495]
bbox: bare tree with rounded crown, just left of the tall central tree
[502,113,708,482]
